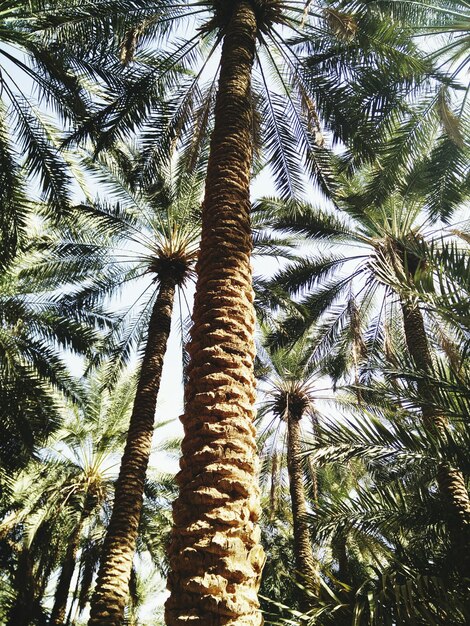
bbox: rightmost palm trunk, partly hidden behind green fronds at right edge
[402,302,470,576]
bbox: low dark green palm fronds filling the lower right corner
[302,368,469,624]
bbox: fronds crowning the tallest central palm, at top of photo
[70,0,431,196]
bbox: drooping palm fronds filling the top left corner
[0,0,176,264]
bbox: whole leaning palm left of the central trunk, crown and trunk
[29,145,289,619]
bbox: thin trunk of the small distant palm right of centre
[287,411,318,610]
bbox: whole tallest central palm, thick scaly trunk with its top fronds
[59,0,436,624]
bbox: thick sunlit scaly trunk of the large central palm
[166,0,264,626]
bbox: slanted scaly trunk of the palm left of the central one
[88,277,175,626]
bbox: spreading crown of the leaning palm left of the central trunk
[25,151,293,372]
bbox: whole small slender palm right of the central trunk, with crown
[258,344,318,610]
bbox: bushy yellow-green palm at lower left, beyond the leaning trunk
[0,366,135,626]
